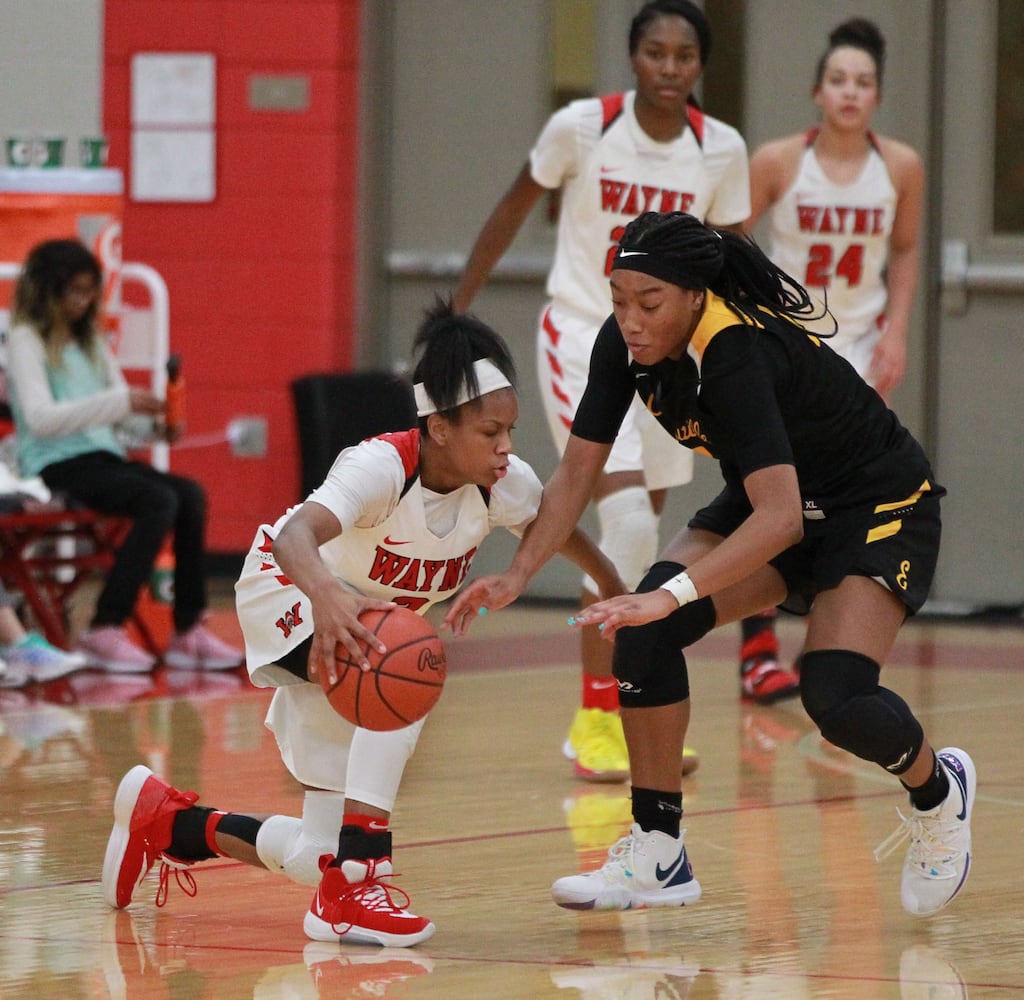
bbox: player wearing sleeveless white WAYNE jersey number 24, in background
[750,18,925,398]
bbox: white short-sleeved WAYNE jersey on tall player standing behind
[529,91,751,327]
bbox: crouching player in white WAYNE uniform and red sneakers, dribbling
[102,305,625,947]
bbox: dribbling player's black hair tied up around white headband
[413,298,516,427]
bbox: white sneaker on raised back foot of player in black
[874,746,978,917]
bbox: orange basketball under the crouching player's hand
[321,607,447,731]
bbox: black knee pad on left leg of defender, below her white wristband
[611,562,715,708]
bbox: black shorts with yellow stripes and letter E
[689,485,945,614]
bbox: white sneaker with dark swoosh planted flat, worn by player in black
[551,823,700,910]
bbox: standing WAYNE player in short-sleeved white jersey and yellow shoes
[454,0,797,781]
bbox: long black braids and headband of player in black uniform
[618,212,827,324]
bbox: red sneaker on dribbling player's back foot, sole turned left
[102,764,199,910]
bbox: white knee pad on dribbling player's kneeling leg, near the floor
[256,791,345,885]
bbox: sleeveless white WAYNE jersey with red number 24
[770,129,897,349]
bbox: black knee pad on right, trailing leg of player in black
[800,649,925,775]
